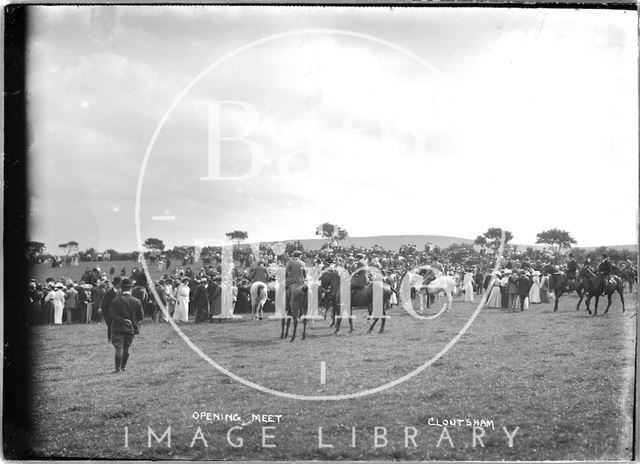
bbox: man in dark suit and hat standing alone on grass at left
[108,278,144,374]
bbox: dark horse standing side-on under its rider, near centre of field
[318,271,392,333]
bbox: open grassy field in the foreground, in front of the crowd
[26,286,636,460]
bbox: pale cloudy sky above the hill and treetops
[27,6,638,252]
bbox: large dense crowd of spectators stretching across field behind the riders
[27,242,633,325]
